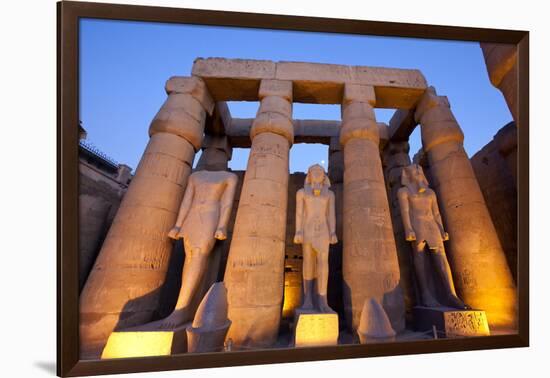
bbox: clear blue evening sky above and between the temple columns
[80,19,512,172]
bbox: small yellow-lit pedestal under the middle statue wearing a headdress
[294,309,338,347]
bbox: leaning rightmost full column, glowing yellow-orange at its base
[415,87,517,330]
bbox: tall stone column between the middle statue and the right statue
[340,84,405,332]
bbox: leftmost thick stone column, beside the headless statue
[80,77,214,357]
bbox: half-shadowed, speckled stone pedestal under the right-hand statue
[413,306,490,337]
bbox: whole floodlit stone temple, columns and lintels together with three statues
[80,58,517,358]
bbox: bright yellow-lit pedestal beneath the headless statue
[101,323,191,360]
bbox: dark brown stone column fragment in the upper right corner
[480,43,518,122]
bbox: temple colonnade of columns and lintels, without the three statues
[80,51,517,358]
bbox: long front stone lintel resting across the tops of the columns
[192,58,427,108]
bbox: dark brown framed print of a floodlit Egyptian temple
[58,1,529,376]
